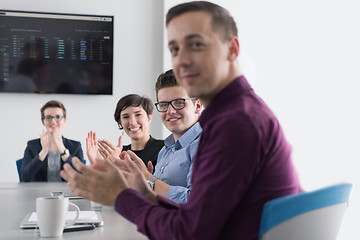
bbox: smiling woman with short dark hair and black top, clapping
[86,94,164,169]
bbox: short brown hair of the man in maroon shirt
[166,1,238,41]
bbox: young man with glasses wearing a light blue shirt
[138,70,202,203]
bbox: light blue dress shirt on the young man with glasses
[154,122,202,203]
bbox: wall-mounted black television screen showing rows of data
[0,9,114,95]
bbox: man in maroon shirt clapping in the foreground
[62,2,301,240]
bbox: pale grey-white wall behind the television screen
[0,0,164,179]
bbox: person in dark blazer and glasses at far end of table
[21,100,84,182]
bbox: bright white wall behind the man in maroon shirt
[164,0,360,240]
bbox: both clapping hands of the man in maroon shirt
[60,151,157,206]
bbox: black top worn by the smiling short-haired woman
[123,136,164,167]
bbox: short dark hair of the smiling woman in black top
[114,94,154,130]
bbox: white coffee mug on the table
[36,196,80,237]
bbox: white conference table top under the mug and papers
[0,182,148,240]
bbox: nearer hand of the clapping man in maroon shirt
[60,159,128,206]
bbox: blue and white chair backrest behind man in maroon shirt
[258,183,352,240]
